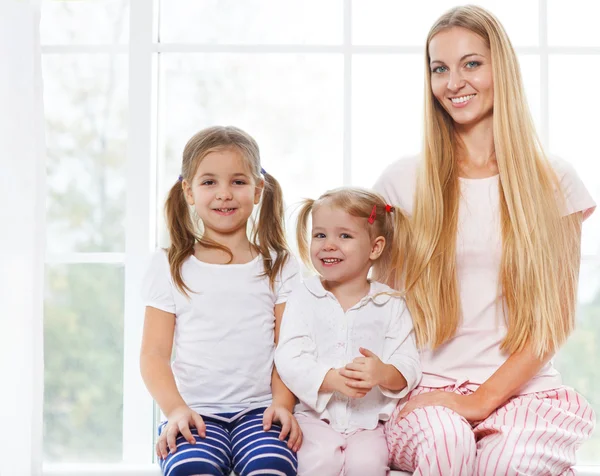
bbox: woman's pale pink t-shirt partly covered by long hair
[374,157,595,393]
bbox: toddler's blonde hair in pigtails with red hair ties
[296,187,410,282]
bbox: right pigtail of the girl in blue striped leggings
[252,171,289,289]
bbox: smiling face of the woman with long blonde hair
[429,27,494,126]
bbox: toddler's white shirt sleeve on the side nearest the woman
[380,299,422,398]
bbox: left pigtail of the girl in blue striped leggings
[165,181,197,296]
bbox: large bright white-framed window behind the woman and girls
[42,0,600,464]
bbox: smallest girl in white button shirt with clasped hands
[275,188,421,476]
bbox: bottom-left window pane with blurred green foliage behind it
[44,264,124,462]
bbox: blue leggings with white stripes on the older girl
[158,408,298,476]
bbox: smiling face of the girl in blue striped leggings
[183,149,263,236]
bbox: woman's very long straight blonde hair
[406,5,581,356]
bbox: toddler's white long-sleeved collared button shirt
[275,276,421,433]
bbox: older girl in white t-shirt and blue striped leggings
[141,127,301,476]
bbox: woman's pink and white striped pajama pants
[385,386,595,476]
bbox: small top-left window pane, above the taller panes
[40,0,129,45]
